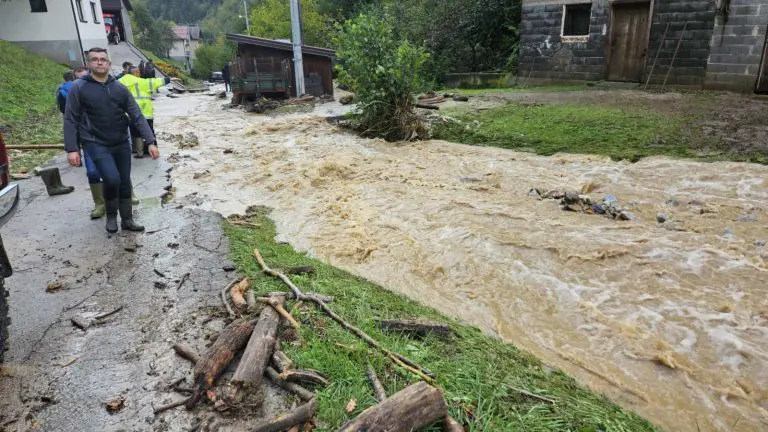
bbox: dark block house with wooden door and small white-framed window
[518,0,768,92]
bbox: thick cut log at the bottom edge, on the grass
[339,382,448,432]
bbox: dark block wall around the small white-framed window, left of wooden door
[518,0,608,82]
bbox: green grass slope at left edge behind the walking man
[0,40,69,172]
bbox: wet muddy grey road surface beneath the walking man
[0,144,292,432]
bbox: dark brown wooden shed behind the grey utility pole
[227,34,336,102]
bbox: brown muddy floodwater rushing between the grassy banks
[158,96,768,432]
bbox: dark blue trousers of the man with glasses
[83,141,131,201]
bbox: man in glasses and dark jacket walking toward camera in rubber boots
[64,48,160,233]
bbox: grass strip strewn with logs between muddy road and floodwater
[224,211,654,432]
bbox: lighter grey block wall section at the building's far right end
[704,0,768,92]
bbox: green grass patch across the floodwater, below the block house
[436,103,697,161]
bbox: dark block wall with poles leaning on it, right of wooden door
[646,0,715,87]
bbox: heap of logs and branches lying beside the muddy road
[155,250,463,432]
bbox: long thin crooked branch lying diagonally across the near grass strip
[253,249,435,384]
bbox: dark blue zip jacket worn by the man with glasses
[64,75,155,152]
